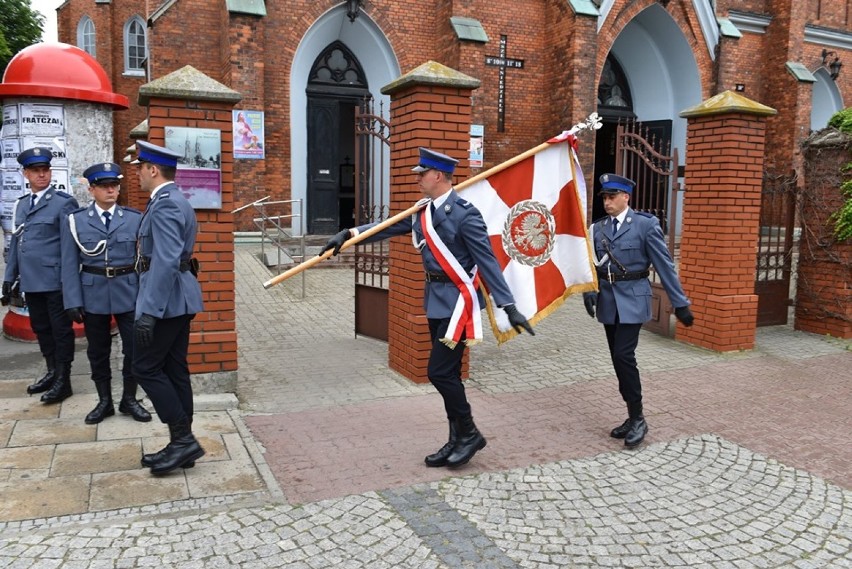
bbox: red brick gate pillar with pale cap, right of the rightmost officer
[677,91,775,352]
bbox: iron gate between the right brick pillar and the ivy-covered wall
[754,172,796,326]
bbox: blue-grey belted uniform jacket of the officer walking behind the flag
[592,208,689,324]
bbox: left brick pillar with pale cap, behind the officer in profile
[135,66,241,393]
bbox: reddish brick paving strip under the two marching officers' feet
[246,354,852,503]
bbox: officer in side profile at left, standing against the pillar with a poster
[133,141,204,475]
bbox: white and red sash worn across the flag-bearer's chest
[420,202,482,349]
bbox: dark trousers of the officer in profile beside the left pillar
[133,314,195,425]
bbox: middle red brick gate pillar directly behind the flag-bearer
[382,61,479,383]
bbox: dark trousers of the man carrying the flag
[426,318,471,419]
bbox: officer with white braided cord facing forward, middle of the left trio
[61,162,151,425]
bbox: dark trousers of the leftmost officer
[26,290,74,365]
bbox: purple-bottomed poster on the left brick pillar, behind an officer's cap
[166,126,222,209]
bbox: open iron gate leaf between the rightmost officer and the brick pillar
[615,120,680,336]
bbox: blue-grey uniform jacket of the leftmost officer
[3,188,80,292]
